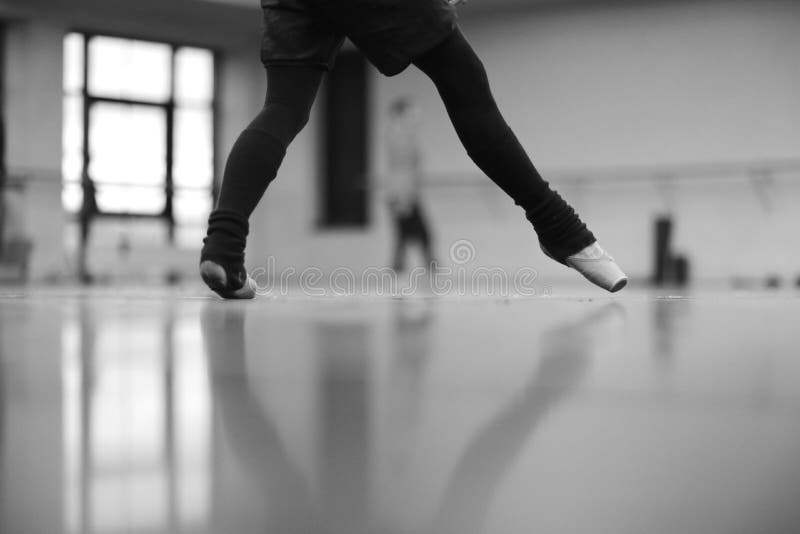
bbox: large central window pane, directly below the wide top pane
[89,103,167,187]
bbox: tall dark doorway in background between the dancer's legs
[318,50,369,228]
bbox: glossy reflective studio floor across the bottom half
[0,291,800,534]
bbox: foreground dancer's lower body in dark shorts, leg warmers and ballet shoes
[200,0,627,298]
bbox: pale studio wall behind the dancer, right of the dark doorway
[253,1,800,284]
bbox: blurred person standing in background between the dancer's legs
[385,97,433,272]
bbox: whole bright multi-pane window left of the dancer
[62,33,214,247]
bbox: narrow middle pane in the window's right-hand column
[173,109,214,187]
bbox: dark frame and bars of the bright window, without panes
[62,29,220,245]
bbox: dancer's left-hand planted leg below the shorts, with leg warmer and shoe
[200,65,325,298]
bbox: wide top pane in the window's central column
[89,37,172,102]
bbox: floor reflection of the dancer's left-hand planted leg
[201,304,319,534]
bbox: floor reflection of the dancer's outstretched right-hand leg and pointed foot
[430,304,622,534]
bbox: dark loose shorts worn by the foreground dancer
[261,0,456,76]
